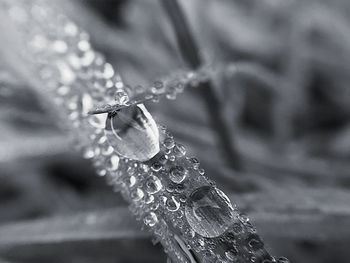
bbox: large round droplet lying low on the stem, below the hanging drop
[185,186,234,238]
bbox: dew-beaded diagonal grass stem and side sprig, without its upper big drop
[4,0,288,263]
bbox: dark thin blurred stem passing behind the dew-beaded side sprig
[161,0,242,170]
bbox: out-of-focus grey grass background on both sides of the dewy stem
[0,0,350,263]
